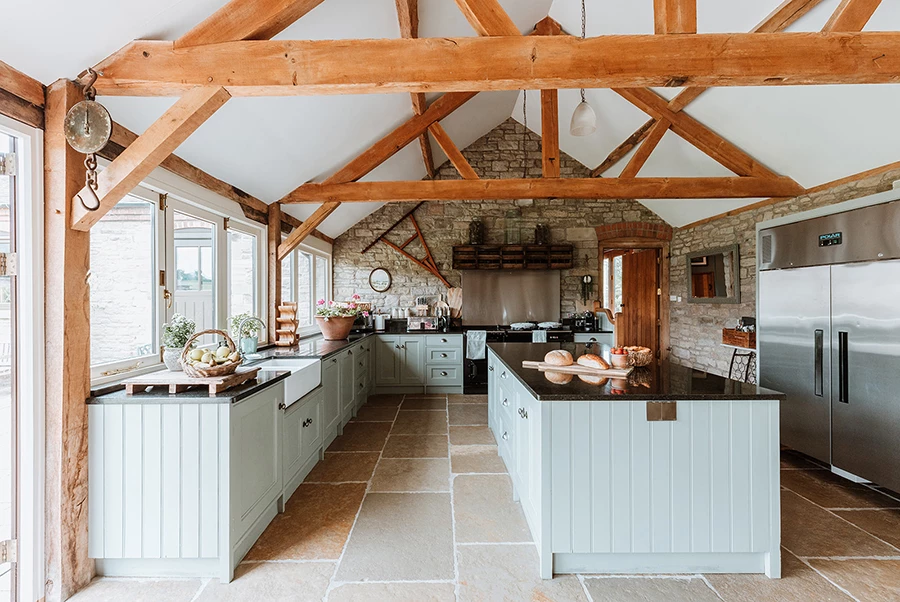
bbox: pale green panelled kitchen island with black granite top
[488,343,782,578]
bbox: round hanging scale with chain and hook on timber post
[63,69,112,211]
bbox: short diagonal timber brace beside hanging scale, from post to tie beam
[72,86,231,231]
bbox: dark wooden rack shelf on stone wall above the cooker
[453,245,575,270]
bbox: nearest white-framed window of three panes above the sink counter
[90,186,265,382]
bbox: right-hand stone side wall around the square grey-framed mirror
[670,170,900,374]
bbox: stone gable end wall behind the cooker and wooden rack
[334,119,663,316]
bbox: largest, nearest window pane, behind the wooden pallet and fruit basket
[90,196,157,365]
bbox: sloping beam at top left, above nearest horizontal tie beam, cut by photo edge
[175,0,322,48]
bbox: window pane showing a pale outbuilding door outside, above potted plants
[174,211,217,336]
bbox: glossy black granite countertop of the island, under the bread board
[488,343,784,401]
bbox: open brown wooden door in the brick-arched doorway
[616,249,659,352]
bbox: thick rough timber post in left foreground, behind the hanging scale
[44,80,94,602]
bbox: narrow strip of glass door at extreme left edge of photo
[0,132,18,602]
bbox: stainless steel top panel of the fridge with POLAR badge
[757,201,900,270]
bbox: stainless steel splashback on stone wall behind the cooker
[462,270,560,325]
